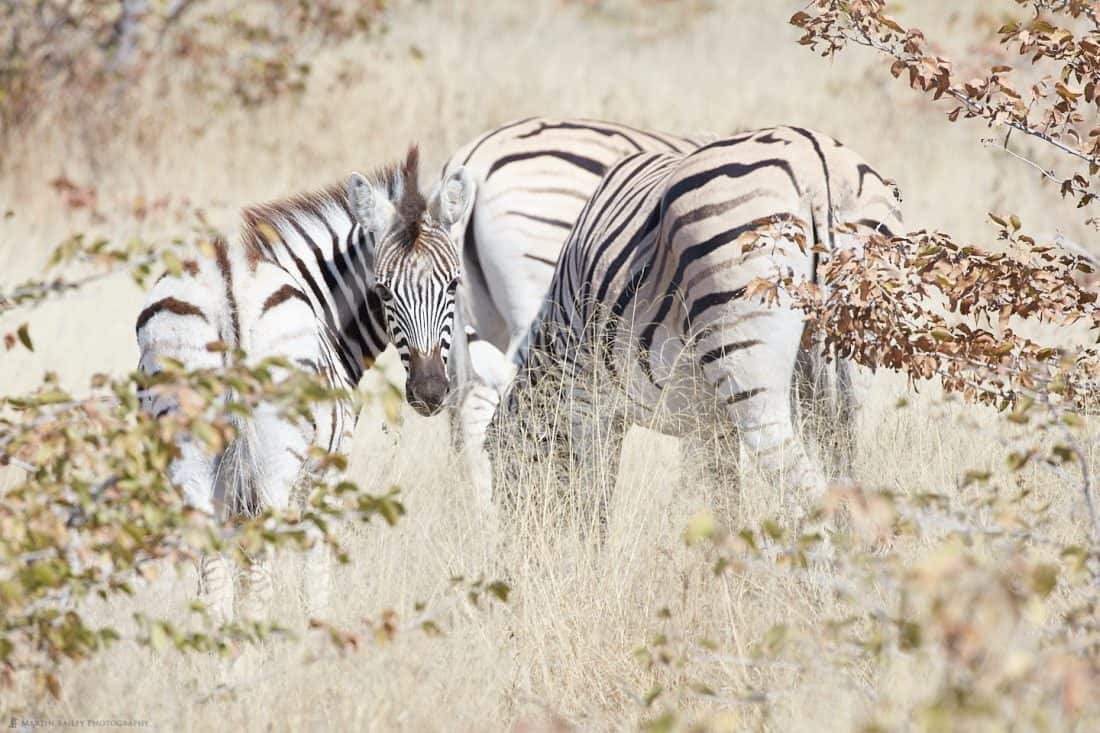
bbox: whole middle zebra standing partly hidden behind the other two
[443,117,884,494]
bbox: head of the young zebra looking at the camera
[348,146,474,416]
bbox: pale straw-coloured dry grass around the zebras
[0,0,1096,731]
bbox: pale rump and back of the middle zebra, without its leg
[443,118,714,351]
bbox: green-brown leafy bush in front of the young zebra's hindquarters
[0,239,403,708]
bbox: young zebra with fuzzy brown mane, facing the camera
[136,147,473,621]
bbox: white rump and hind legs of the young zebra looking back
[138,231,355,624]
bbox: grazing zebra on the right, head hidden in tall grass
[481,128,900,512]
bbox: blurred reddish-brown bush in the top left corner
[0,0,383,161]
